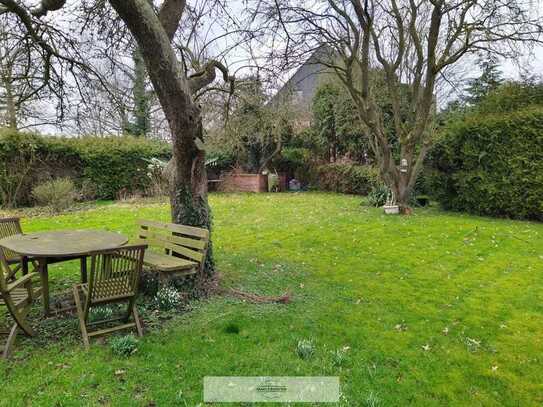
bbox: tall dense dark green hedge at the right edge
[430,107,543,220]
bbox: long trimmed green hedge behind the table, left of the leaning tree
[0,129,171,206]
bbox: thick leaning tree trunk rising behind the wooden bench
[110,0,213,277]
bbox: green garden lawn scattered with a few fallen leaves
[0,193,543,406]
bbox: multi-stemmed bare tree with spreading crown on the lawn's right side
[253,0,542,208]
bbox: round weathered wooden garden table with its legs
[0,230,128,315]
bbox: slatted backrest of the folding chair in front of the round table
[87,245,147,306]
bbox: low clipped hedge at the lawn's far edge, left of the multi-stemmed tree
[315,164,381,195]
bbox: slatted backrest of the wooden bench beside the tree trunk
[138,220,209,264]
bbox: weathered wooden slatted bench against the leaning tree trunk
[138,220,209,280]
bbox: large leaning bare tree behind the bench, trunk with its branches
[0,0,242,273]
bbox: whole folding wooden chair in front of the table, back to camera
[73,245,147,349]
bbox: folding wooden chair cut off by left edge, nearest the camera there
[0,250,42,359]
